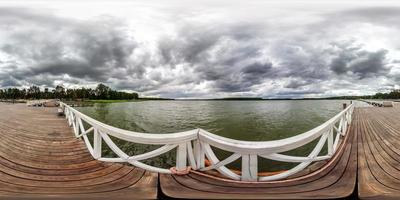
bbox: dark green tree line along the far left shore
[0,84,139,100]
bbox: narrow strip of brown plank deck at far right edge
[354,103,400,199]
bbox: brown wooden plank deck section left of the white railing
[0,103,158,199]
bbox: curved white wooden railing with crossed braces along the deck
[60,102,354,181]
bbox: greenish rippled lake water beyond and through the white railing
[78,100,349,171]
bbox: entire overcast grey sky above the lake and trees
[0,0,400,98]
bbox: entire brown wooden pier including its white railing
[0,103,400,199]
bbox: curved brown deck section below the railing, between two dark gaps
[160,109,361,199]
